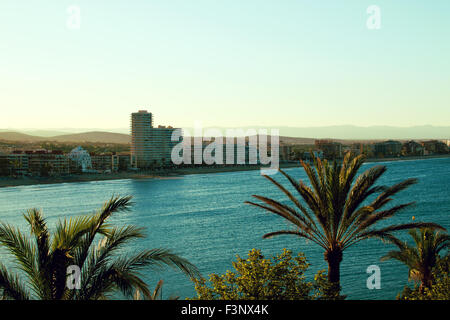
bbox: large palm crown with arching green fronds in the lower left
[0,196,199,300]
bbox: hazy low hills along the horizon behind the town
[0,125,450,144]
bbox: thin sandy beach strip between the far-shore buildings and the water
[0,154,450,189]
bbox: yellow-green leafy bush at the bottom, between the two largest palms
[194,249,344,300]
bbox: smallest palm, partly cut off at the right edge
[381,228,450,291]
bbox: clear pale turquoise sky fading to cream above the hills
[0,0,450,129]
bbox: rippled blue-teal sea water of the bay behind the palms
[0,158,450,299]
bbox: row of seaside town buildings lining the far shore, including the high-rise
[0,109,450,177]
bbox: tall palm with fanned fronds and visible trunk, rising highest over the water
[246,153,443,285]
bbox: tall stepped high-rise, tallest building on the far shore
[131,110,178,169]
